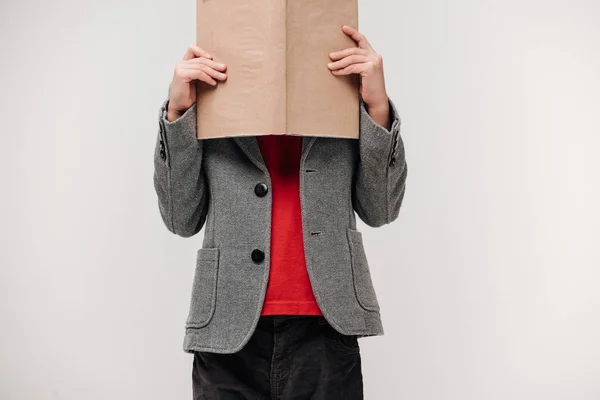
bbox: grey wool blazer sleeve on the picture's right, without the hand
[352,98,408,227]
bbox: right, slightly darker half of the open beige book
[286,0,360,138]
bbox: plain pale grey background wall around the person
[0,0,600,400]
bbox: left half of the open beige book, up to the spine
[196,0,286,139]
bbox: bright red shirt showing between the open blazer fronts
[256,135,322,315]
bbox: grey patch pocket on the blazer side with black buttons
[186,248,219,328]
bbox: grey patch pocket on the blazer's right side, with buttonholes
[347,228,379,311]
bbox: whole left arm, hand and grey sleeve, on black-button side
[154,45,227,237]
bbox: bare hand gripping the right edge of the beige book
[327,25,388,109]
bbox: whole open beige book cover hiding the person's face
[196,0,359,139]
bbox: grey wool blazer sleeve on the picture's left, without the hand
[154,99,208,237]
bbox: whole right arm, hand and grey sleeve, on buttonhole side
[328,25,408,227]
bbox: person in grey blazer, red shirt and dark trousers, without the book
[154,26,407,400]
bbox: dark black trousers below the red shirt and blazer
[192,315,363,400]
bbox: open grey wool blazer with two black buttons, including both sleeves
[154,91,407,353]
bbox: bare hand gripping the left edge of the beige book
[167,45,227,121]
